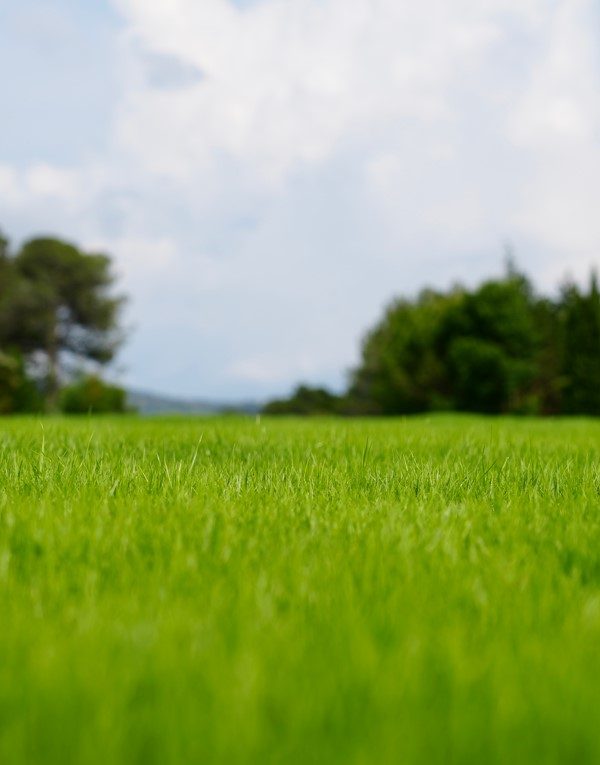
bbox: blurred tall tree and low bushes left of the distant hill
[0,232,125,414]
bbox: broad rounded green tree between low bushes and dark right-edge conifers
[349,264,539,414]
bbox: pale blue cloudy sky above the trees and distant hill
[0,0,600,400]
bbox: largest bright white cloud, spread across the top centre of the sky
[108,0,531,182]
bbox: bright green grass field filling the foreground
[0,417,600,765]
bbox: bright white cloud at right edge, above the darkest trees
[510,0,600,286]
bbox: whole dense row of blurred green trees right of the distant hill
[264,262,600,415]
